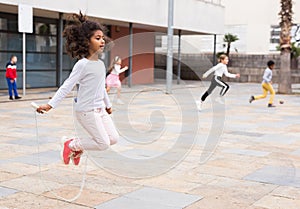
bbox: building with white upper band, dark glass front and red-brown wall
[0,0,224,88]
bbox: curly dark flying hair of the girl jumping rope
[63,11,109,59]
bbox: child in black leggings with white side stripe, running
[198,54,240,111]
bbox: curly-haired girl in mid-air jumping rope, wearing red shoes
[37,12,119,165]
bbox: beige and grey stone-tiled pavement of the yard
[0,81,300,209]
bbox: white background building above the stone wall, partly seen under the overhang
[176,0,300,54]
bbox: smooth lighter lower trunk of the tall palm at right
[278,50,292,94]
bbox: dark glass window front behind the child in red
[0,12,77,89]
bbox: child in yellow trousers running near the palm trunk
[249,60,275,107]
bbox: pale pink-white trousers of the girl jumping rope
[70,108,119,150]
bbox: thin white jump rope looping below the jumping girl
[31,98,88,202]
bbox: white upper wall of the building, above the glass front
[0,0,224,34]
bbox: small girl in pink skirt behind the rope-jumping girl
[106,56,128,104]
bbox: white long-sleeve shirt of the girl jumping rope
[48,58,111,111]
